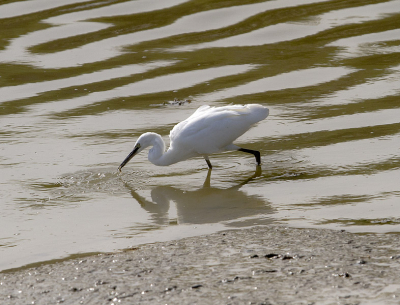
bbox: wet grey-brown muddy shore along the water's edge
[0,226,400,305]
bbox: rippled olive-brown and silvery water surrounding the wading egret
[0,0,400,270]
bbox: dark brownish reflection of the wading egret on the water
[124,167,273,226]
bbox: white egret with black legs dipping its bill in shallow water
[118,104,269,171]
